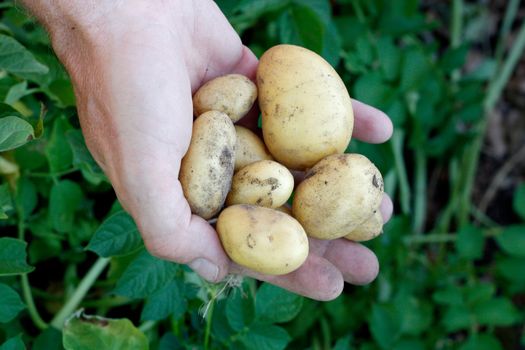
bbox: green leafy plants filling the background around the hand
[0,0,525,350]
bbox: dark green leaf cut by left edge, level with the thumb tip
[0,237,35,276]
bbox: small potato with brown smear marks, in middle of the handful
[226,160,294,208]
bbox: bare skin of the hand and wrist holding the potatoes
[21,0,392,300]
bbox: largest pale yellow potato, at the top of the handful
[257,45,354,170]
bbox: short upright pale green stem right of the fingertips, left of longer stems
[413,148,427,234]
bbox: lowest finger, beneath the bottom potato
[231,254,344,301]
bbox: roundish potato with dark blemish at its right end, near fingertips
[292,154,383,239]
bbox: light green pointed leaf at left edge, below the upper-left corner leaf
[0,116,35,152]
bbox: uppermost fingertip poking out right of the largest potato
[352,100,393,143]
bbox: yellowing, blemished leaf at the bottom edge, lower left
[63,311,149,350]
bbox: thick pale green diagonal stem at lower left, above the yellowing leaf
[51,257,110,329]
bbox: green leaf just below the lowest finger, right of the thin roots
[255,283,303,323]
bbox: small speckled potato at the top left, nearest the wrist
[193,74,257,122]
